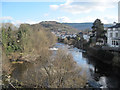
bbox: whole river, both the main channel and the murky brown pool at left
[12,43,120,88]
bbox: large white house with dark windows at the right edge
[107,23,120,47]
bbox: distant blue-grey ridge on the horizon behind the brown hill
[63,23,112,30]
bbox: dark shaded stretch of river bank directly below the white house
[86,46,120,68]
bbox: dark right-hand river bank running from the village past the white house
[60,39,120,68]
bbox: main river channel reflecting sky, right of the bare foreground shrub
[54,43,120,88]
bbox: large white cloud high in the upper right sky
[50,0,117,14]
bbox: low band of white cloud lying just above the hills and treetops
[0,15,118,26]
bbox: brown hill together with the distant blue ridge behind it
[20,21,112,33]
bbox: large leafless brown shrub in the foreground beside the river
[20,50,86,88]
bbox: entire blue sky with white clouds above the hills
[0,0,118,24]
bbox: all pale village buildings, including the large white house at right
[52,23,120,48]
